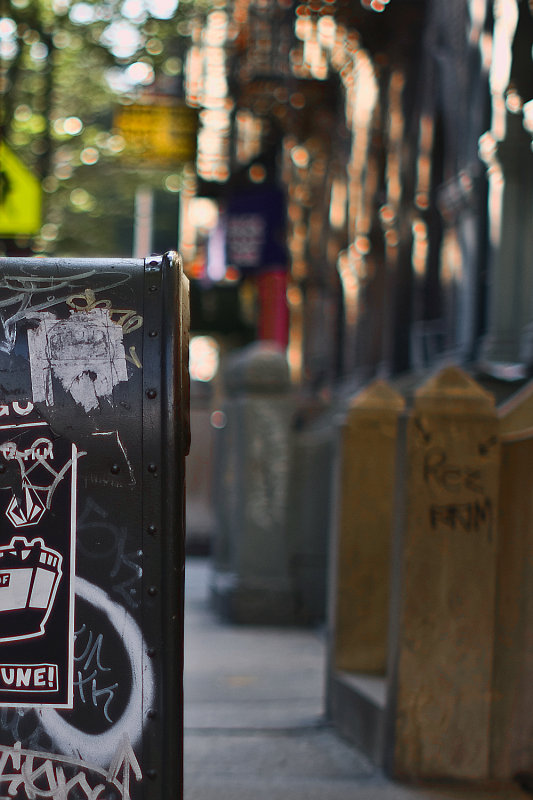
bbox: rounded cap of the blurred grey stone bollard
[224,342,291,395]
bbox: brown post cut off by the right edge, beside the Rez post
[491,383,533,779]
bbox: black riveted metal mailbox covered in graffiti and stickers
[0,253,189,800]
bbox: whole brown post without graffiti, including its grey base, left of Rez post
[326,381,404,764]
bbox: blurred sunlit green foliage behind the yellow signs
[0,0,209,256]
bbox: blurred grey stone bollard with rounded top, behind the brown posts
[211,342,295,625]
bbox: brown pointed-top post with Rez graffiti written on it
[385,367,499,780]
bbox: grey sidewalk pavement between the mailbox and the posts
[184,558,531,800]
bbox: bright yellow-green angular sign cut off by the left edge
[0,141,41,237]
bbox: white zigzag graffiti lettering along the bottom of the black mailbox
[0,734,142,800]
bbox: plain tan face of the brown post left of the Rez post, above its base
[333,381,404,674]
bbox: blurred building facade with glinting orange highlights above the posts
[184,0,533,390]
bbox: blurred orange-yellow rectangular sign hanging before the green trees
[114,103,198,163]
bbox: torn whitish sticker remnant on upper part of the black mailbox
[28,308,128,411]
